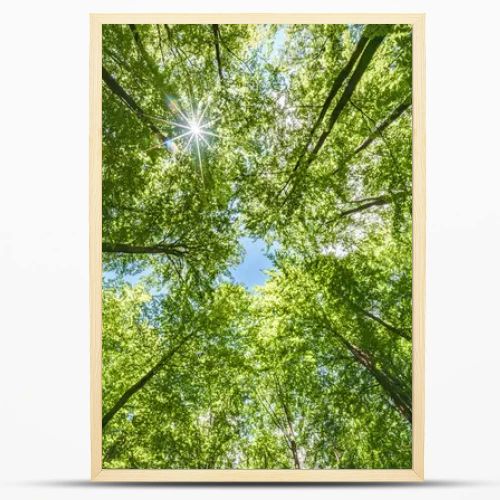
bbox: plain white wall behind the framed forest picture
[0,0,500,499]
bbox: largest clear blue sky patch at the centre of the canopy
[231,237,273,290]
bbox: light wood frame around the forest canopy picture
[89,14,425,483]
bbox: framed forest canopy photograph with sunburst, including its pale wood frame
[90,14,425,482]
